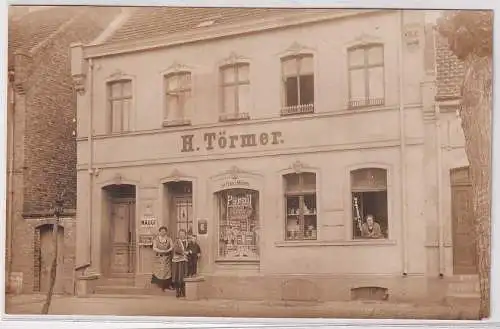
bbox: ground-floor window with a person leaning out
[351,168,388,239]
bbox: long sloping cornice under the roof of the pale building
[84,9,389,58]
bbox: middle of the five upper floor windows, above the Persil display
[220,63,251,121]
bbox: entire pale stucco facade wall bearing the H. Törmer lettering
[72,11,474,298]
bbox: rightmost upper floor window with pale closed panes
[348,44,385,108]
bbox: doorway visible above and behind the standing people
[164,181,196,239]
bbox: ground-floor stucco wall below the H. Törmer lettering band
[78,145,434,275]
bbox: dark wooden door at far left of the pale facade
[102,185,136,277]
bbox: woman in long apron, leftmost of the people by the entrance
[151,226,173,291]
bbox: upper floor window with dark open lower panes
[281,54,314,115]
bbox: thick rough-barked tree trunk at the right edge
[460,55,492,319]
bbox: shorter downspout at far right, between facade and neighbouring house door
[435,104,445,278]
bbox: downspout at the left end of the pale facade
[87,58,94,265]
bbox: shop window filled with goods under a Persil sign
[217,189,259,260]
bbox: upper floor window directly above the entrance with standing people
[163,72,192,126]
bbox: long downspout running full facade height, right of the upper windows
[398,10,408,276]
